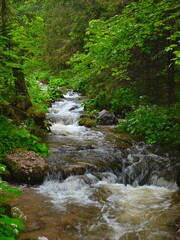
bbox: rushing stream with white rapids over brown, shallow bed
[15,92,180,240]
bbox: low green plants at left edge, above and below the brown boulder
[0,115,49,240]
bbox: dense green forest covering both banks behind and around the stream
[0,0,180,239]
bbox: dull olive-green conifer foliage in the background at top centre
[44,0,128,72]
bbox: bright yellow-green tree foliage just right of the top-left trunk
[11,1,45,73]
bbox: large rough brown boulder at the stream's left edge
[5,151,50,184]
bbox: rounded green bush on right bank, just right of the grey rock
[119,105,180,147]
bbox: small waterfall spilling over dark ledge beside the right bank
[119,144,179,188]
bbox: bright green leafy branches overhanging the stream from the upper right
[69,0,179,106]
